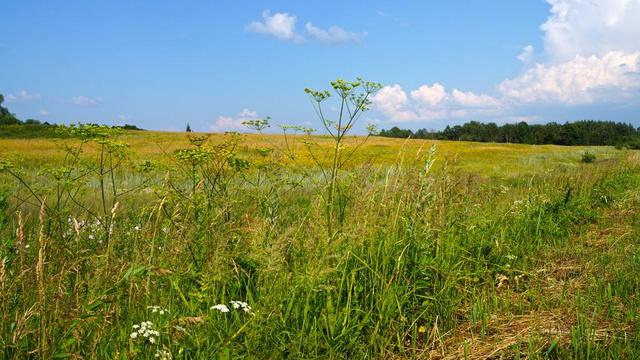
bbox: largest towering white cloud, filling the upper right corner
[498,0,640,106]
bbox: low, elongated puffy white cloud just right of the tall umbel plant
[373,83,503,122]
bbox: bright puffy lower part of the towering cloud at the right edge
[499,51,640,105]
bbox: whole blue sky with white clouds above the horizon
[0,0,640,132]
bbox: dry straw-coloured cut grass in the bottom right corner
[423,201,635,359]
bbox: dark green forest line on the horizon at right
[379,120,640,149]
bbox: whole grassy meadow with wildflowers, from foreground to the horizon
[0,132,640,359]
